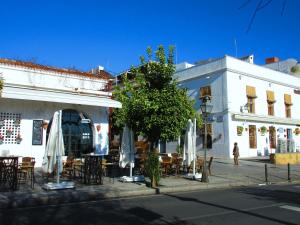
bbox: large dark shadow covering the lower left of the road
[0,192,191,225]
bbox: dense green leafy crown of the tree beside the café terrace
[113,46,196,149]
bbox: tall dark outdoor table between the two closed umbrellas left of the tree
[83,154,103,184]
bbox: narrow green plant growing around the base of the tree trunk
[146,151,160,187]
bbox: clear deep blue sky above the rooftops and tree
[0,0,300,73]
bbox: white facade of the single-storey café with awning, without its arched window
[0,61,121,166]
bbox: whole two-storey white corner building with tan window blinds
[175,56,300,158]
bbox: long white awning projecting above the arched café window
[2,86,122,108]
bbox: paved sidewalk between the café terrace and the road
[0,157,300,209]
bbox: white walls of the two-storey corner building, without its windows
[175,56,300,158]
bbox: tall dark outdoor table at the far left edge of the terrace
[0,156,19,190]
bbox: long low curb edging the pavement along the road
[0,181,300,210]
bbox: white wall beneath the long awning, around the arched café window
[0,98,108,166]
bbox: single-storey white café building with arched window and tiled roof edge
[0,59,121,166]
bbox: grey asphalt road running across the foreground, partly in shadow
[0,185,300,225]
